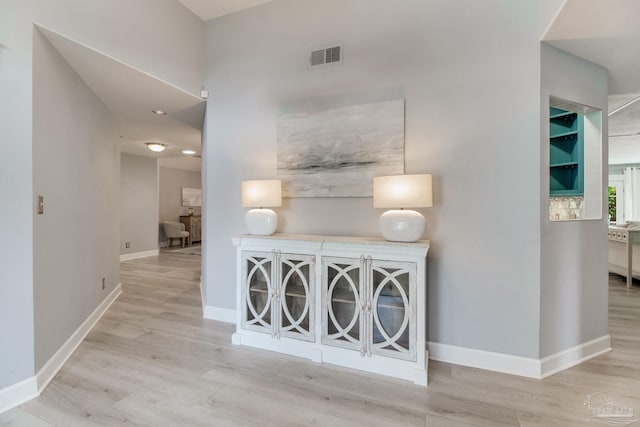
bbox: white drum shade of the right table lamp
[373,174,433,209]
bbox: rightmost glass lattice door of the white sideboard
[370,260,416,360]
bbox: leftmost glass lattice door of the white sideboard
[242,252,274,333]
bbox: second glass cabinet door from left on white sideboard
[278,254,315,341]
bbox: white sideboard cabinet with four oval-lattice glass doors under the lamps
[233,234,429,386]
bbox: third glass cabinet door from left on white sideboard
[322,257,363,351]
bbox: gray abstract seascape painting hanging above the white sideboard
[278,100,404,197]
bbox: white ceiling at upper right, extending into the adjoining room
[543,0,640,164]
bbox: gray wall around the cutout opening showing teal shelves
[540,43,608,357]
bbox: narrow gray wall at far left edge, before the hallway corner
[0,0,35,390]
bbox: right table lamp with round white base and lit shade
[373,174,433,242]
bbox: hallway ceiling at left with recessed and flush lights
[38,27,205,167]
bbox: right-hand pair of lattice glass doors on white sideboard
[322,256,416,360]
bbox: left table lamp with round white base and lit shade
[242,179,282,236]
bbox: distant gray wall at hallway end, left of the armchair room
[120,153,158,255]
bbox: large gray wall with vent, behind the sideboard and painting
[203,0,540,358]
